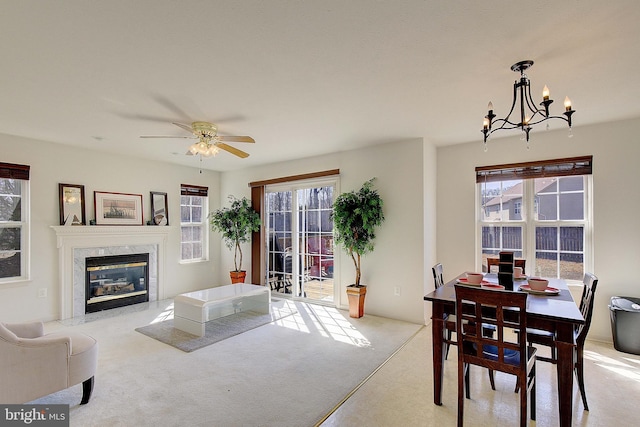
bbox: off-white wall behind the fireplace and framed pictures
[0,134,220,322]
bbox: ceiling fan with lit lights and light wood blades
[140,122,256,159]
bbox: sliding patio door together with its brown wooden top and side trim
[249,169,340,300]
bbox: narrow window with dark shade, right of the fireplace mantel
[180,184,209,262]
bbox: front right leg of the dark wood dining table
[556,323,575,427]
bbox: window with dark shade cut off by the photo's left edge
[0,163,30,283]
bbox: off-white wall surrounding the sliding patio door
[220,139,435,323]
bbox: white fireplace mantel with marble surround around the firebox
[51,225,171,320]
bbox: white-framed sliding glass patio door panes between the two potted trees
[265,182,335,303]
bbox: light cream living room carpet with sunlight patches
[33,300,422,427]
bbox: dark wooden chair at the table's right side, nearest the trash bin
[516,273,598,411]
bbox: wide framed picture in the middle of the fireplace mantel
[93,191,143,225]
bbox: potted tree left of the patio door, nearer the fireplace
[209,196,260,283]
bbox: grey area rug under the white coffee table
[136,305,296,353]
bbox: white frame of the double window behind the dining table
[476,174,594,283]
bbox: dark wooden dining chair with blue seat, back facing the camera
[455,285,536,426]
